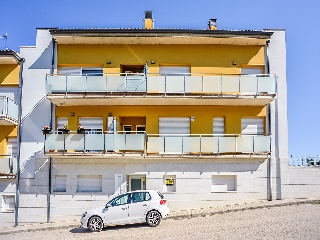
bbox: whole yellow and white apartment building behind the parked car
[15,12,288,221]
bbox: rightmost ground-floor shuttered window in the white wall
[211,175,237,192]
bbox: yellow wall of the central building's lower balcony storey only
[56,106,266,134]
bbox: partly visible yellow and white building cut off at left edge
[0,50,22,222]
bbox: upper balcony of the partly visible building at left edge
[0,96,18,125]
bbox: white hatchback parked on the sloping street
[80,190,169,232]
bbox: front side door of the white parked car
[104,194,130,225]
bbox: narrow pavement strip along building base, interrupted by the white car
[0,199,320,235]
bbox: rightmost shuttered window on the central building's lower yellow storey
[241,118,264,135]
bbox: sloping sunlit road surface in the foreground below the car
[1,204,320,240]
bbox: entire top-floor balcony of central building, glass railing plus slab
[46,74,277,106]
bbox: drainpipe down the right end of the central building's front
[265,40,272,201]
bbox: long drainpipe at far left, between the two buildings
[14,59,25,227]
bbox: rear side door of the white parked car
[129,192,151,222]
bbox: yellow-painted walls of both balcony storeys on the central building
[56,44,266,134]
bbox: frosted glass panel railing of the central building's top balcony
[46,73,276,95]
